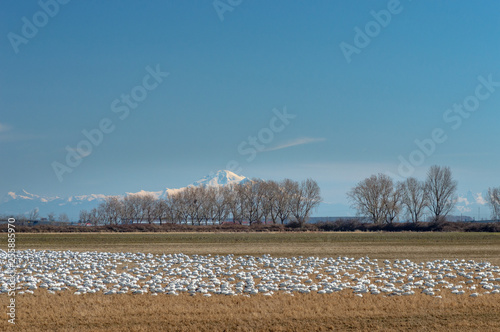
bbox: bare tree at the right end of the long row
[291,179,321,226]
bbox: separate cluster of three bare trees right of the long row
[347,166,457,224]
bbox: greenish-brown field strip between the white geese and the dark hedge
[11,232,500,265]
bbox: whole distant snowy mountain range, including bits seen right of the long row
[0,170,490,221]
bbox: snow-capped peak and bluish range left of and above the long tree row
[0,170,249,220]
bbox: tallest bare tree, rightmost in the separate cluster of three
[425,165,457,221]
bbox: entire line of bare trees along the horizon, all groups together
[8,165,500,225]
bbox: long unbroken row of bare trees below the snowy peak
[80,179,321,225]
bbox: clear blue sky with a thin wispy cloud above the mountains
[0,0,500,214]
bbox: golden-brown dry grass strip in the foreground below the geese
[0,292,500,331]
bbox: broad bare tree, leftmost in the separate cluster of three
[347,173,394,224]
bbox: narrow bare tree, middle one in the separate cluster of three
[402,177,428,223]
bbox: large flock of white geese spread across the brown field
[0,250,500,298]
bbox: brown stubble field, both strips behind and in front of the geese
[0,232,500,331]
